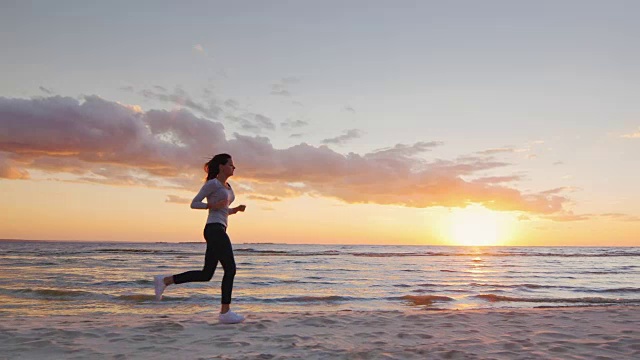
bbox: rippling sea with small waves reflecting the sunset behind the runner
[0,241,640,317]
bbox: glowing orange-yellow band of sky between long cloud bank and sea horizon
[0,180,640,246]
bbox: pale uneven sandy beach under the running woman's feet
[0,307,640,359]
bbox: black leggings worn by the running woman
[173,223,236,304]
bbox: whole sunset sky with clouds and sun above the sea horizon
[0,0,640,246]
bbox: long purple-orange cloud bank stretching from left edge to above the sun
[0,96,569,216]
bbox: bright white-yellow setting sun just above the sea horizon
[449,205,502,246]
